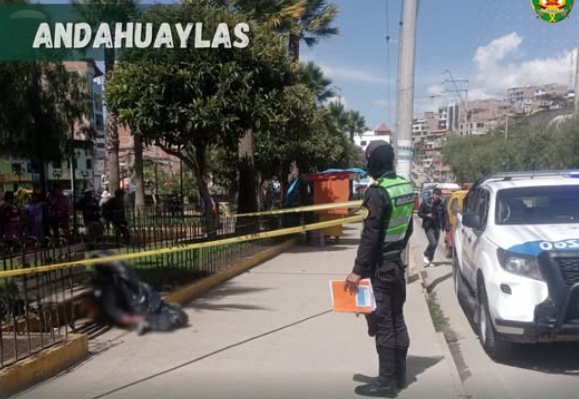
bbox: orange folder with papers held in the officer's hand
[330,279,376,313]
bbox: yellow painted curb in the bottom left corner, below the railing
[0,334,88,398]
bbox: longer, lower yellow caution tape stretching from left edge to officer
[0,216,362,279]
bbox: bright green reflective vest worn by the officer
[376,176,414,243]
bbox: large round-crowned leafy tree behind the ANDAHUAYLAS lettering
[106,0,297,227]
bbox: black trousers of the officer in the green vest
[367,261,410,389]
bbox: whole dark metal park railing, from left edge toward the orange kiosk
[0,203,362,370]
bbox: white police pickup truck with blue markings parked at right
[454,171,579,360]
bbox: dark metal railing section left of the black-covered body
[0,237,85,369]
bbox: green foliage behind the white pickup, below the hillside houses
[443,118,579,183]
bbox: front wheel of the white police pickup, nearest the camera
[477,284,512,361]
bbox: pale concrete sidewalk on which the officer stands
[14,226,458,399]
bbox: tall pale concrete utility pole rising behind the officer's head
[396,0,418,180]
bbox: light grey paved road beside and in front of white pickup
[411,217,579,399]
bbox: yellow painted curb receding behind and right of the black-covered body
[164,237,299,304]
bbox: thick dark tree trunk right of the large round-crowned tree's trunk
[237,129,257,213]
